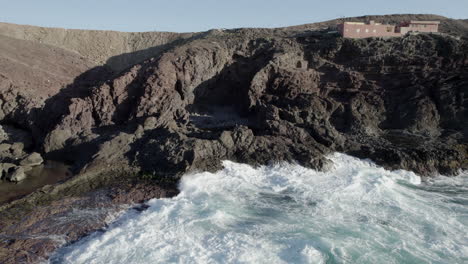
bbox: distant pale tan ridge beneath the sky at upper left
[0,23,193,71]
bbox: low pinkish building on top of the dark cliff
[338,20,440,38]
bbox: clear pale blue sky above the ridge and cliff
[0,0,468,32]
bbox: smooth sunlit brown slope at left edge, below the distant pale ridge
[0,35,95,113]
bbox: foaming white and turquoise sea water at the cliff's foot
[50,153,468,264]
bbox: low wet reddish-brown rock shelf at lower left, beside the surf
[0,183,177,264]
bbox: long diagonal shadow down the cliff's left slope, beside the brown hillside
[30,32,213,170]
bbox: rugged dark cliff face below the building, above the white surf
[2,14,468,184]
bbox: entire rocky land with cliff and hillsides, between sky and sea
[0,15,468,263]
